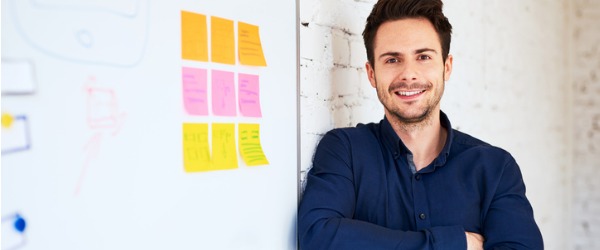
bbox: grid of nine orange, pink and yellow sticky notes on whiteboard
[181,11,269,173]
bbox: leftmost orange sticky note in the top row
[181,11,208,62]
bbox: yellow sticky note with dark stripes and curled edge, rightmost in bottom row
[238,123,269,166]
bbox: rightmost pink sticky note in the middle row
[238,74,262,117]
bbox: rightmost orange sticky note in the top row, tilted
[238,22,267,66]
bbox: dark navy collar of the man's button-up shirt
[381,111,454,169]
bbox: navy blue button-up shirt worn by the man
[298,112,543,250]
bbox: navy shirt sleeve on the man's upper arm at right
[483,156,544,249]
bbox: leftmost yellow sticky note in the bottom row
[183,123,212,173]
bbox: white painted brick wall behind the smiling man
[300,0,584,249]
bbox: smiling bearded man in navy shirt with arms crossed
[298,0,543,250]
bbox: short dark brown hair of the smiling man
[363,0,452,67]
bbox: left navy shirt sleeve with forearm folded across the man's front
[298,132,467,250]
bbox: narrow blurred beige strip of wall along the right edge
[569,0,600,249]
